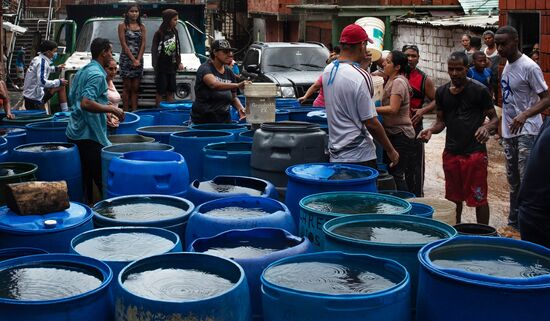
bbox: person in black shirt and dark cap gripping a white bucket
[191,39,250,124]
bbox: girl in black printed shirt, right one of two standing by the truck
[151,9,183,107]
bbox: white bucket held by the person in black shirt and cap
[244,83,277,124]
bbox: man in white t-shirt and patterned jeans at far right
[495,26,550,229]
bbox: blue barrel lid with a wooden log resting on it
[0,202,93,234]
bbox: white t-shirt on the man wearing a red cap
[323,62,377,163]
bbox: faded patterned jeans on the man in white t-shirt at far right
[502,135,537,228]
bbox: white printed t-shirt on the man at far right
[500,55,548,138]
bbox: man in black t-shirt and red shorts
[418,52,498,224]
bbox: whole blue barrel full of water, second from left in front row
[116,253,250,321]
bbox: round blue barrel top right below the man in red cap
[285,163,378,184]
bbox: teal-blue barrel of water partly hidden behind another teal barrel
[300,192,411,250]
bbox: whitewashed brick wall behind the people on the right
[392,24,490,86]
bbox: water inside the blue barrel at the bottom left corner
[0,263,103,301]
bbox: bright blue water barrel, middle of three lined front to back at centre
[185,196,296,246]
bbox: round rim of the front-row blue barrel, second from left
[117,252,248,305]
